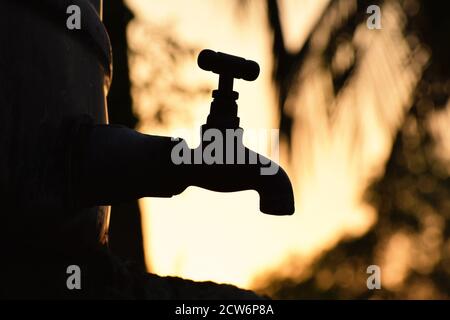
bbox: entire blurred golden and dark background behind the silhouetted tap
[103,0,450,299]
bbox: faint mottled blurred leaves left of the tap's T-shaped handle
[129,18,211,129]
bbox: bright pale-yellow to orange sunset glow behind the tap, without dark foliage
[128,0,426,288]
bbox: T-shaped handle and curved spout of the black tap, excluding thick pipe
[183,50,294,215]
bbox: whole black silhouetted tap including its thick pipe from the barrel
[69,50,295,215]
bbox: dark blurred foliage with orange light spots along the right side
[256,0,450,299]
